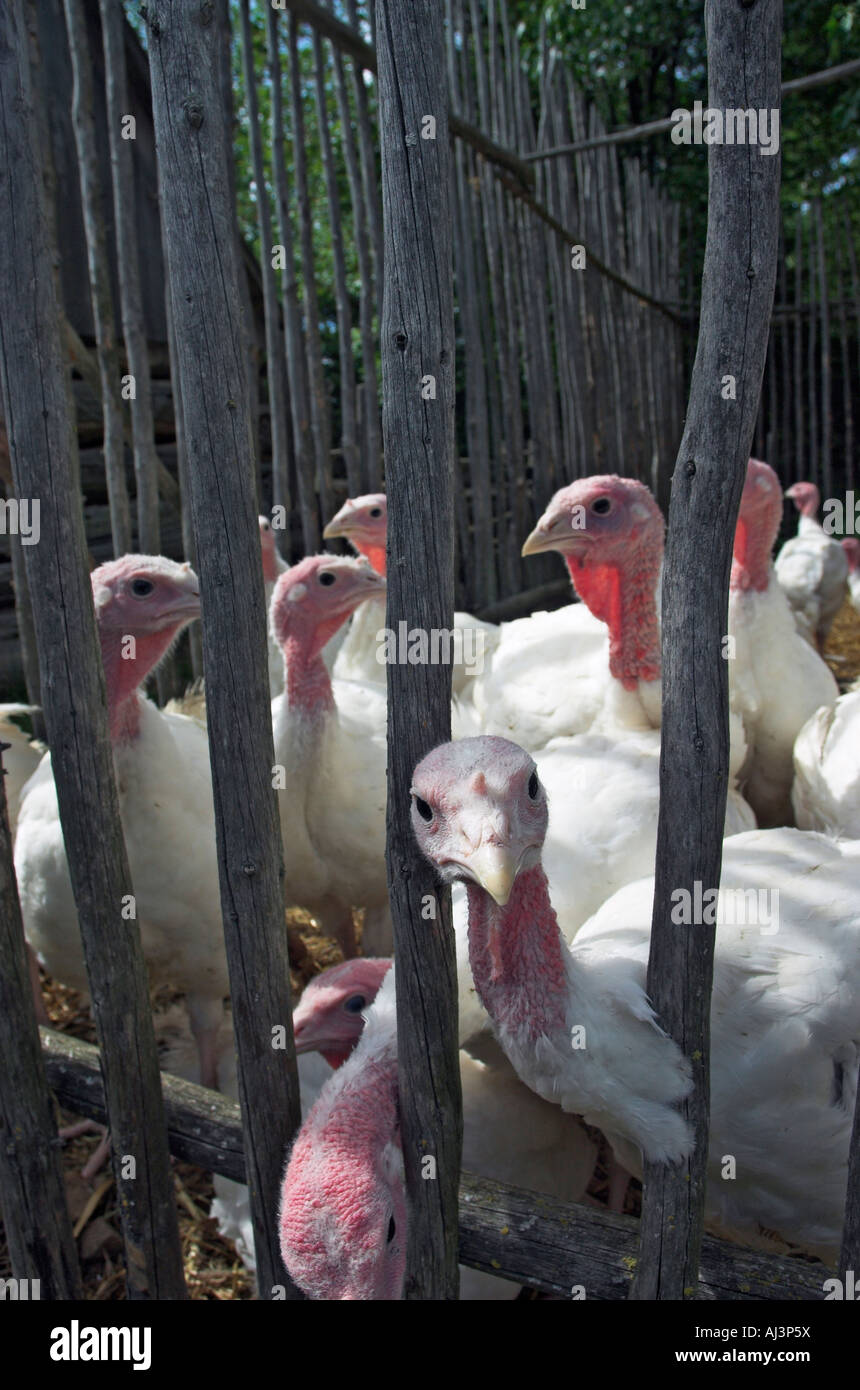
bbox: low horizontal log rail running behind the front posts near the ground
[40,1029,829,1302]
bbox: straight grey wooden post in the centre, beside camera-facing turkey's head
[377,0,463,1298]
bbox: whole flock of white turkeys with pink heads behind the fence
[3,459,860,1300]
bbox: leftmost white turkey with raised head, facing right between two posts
[15,555,228,1086]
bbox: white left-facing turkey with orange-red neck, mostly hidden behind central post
[322,492,499,696]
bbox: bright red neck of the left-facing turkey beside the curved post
[565,539,663,691]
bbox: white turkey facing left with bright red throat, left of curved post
[472,474,663,749]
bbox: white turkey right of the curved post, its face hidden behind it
[728,459,839,827]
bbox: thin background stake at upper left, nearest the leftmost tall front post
[64,0,132,555]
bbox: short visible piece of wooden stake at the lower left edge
[0,772,82,1298]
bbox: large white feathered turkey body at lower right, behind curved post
[571,830,860,1264]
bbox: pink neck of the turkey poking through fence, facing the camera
[467,865,570,1043]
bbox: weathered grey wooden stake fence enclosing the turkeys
[0,0,860,1298]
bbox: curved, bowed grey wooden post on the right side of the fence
[631,0,782,1300]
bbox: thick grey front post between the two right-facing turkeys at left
[147,0,300,1298]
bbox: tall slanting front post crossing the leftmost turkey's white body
[0,0,185,1298]
